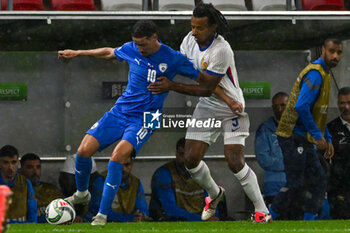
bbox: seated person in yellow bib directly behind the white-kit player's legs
[149,137,228,221]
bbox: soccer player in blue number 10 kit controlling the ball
[58,20,220,225]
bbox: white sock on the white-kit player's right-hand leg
[234,164,269,213]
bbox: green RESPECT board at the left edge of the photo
[0,83,27,101]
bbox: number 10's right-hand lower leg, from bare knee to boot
[91,140,134,225]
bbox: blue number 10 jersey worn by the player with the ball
[112,42,199,115]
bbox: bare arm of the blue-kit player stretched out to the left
[58,47,115,59]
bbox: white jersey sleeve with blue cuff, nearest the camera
[206,47,232,76]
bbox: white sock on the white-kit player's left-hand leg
[186,160,220,199]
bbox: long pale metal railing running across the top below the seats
[0,11,350,20]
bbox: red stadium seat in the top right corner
[302,0,346,11]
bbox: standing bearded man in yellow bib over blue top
[270,39,343,220]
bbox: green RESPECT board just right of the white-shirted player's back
[239,82,270,99]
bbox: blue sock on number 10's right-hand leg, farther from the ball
[98,161,123,215]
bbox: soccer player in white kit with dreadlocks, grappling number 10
[148,3,272,222]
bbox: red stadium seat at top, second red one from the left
[50,0,96,11]
